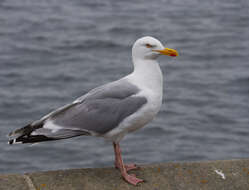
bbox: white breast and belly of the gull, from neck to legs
[104,59,163,142]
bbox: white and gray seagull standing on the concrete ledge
[8,36,178,185]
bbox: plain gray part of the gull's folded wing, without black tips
[44,79,147,135]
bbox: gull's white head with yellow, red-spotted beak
[132,36,178,61]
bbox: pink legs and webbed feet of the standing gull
[113,143,143,185]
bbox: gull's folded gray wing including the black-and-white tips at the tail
[9,79,147,144]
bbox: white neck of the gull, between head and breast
[129,59,163,94]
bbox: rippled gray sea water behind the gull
[0,0,249,173]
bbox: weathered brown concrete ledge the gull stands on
[0,159,249,190]
